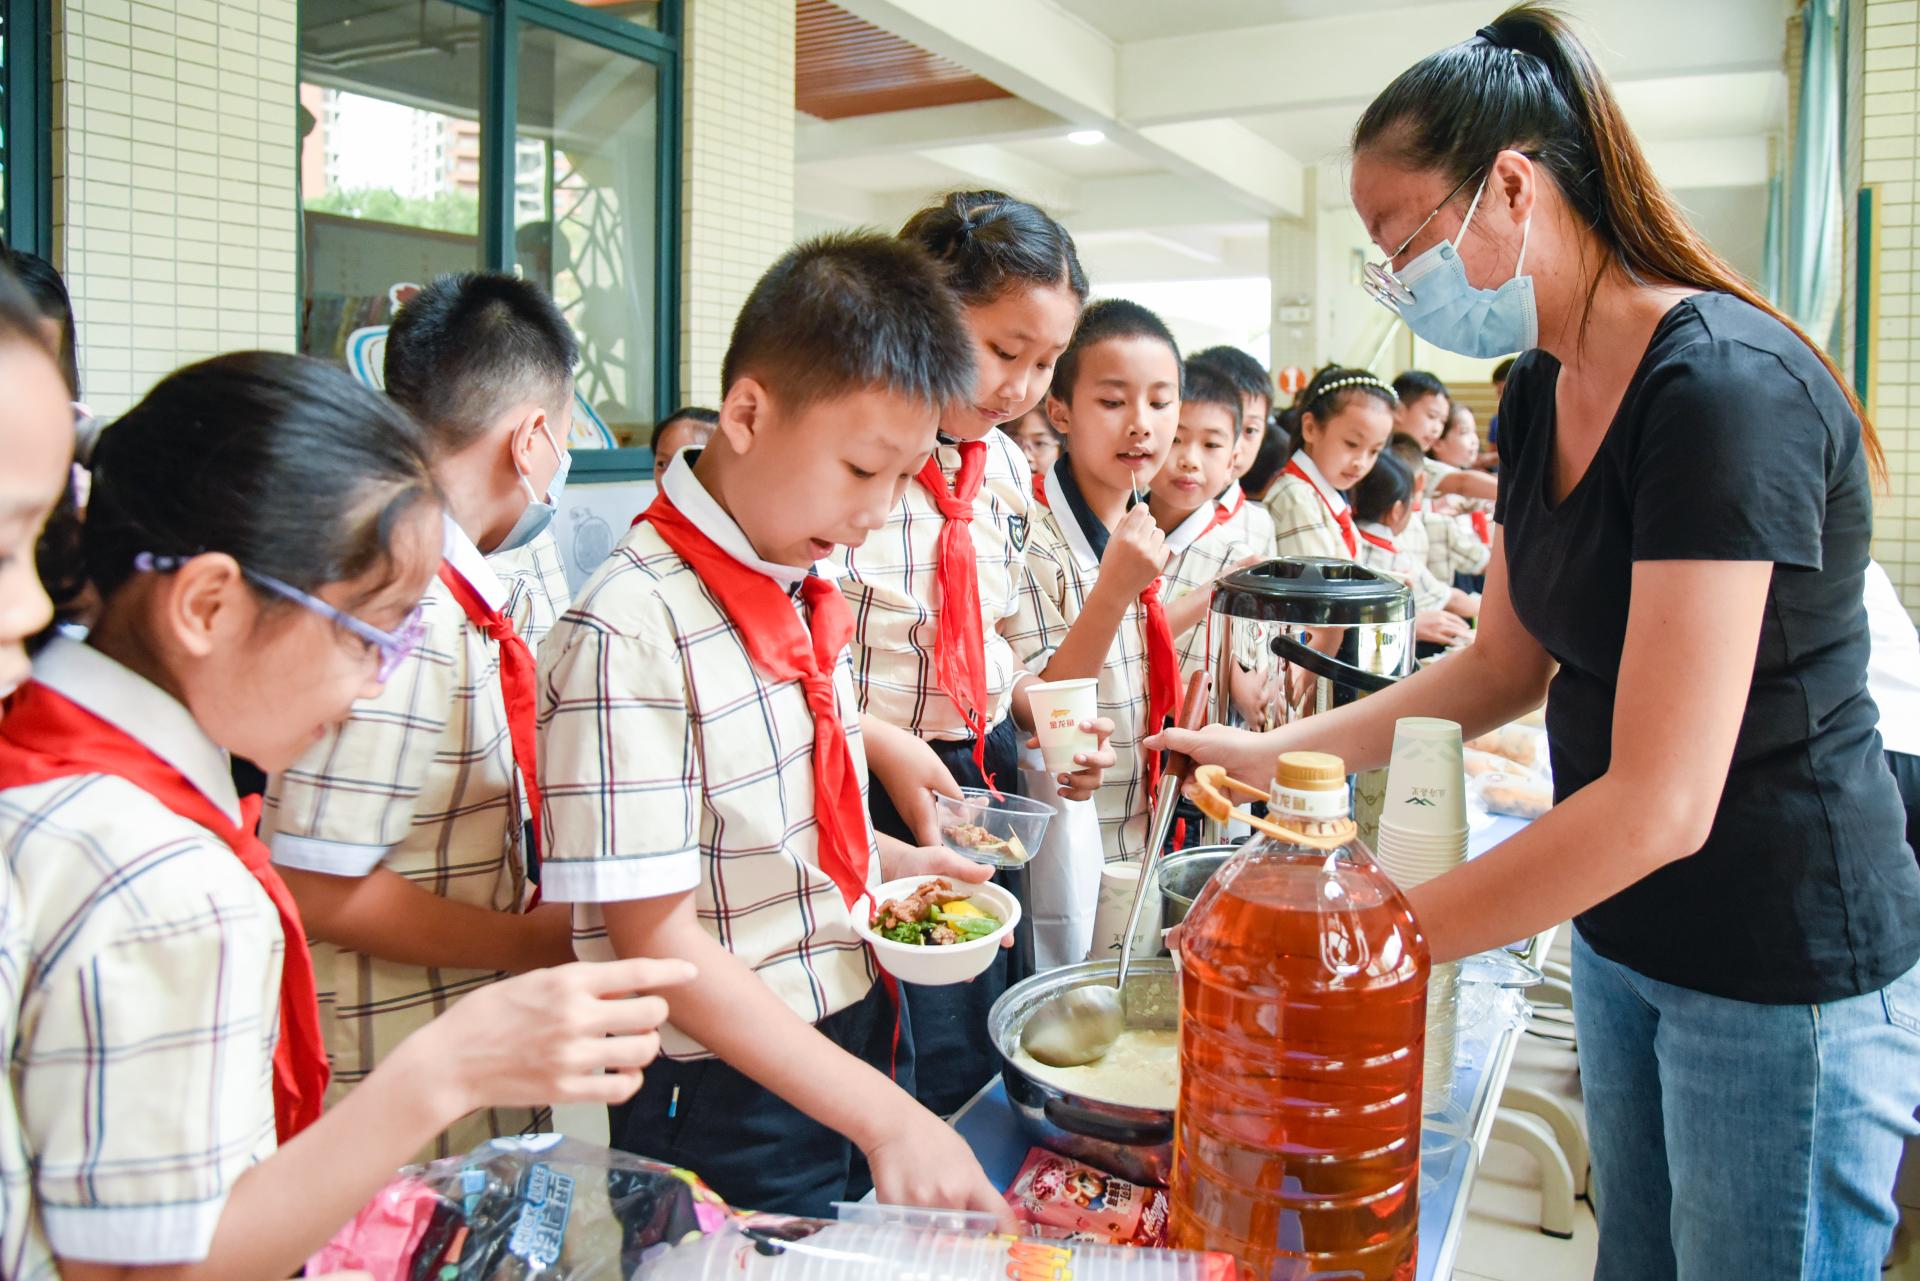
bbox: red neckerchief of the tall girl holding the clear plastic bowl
[916,440,993,787]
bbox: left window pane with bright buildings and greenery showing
[300,0,486,370]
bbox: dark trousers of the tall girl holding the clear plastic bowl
[868,718,1033,1116]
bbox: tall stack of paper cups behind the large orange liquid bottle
[1375,716,1467,1112]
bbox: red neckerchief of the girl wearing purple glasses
[0,682,326,1143]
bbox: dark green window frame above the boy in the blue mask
[299,0,684,466]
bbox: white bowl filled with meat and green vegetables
[854,876,1020,987]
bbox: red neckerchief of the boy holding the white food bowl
[634,490,894,1068]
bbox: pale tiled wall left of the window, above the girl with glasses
[54,0,298,413]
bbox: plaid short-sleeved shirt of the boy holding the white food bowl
[540,457,879,1058]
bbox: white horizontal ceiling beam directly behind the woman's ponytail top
[1117,0,1786,127]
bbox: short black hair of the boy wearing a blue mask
[386,271,580,451]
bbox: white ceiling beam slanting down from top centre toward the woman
[841,0,1302,217]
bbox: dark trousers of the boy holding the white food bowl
[607,983,914,1218]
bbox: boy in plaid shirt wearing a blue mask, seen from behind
[265,273,578,1156]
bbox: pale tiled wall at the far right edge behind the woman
[1849,0,1920,620]
